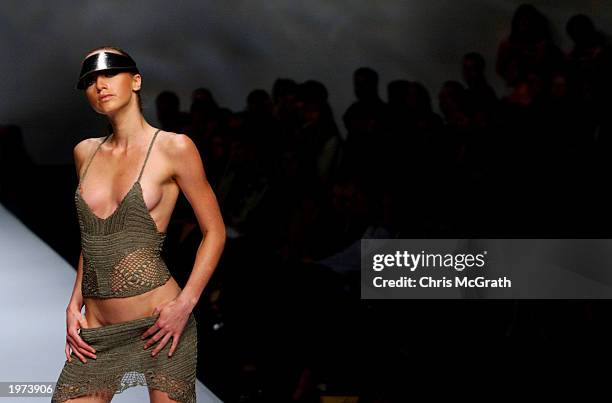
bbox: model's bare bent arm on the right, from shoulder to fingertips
[142,134,225,356]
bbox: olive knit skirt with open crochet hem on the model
[51,313,198,403]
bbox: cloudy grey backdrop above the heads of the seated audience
[0,0,612,164]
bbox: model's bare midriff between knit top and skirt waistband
[83,277,181,328]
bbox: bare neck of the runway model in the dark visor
[108,103,154,150]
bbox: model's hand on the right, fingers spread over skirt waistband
[141,298,191,357]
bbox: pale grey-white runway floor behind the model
[0,205,221,403]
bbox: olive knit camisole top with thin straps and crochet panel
[74,130,171,298]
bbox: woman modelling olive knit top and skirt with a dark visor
[52,46,225,402]
